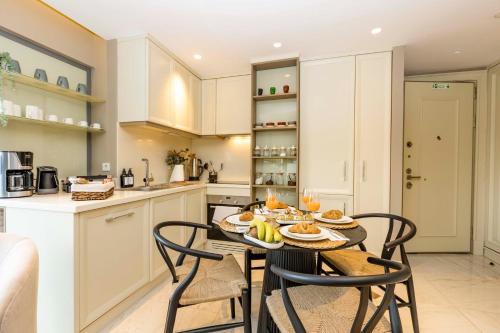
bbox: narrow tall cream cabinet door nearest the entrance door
[354,52,392,253]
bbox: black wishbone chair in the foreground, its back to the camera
[266,258,411,333]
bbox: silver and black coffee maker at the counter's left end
[0,151,34,198]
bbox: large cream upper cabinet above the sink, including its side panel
[117,37,201,134]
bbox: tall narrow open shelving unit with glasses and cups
[251,58,300,206]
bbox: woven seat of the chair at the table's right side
[321,250,384,276]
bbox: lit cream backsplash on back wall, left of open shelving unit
[192,135,251,181]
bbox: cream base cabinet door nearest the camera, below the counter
[79,200,150,329]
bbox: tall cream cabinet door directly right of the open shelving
[299,57,356,195]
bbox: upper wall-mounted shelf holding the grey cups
[0,70,106,103]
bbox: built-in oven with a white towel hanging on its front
[207,195,250,241]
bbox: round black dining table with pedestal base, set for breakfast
[218,219,366,332]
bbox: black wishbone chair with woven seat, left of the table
[153,221,252,333]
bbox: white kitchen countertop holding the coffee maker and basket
[0,182,207,213]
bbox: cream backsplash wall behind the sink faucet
[116,124,191,186]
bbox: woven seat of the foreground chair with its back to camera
[266,285,391,333]
